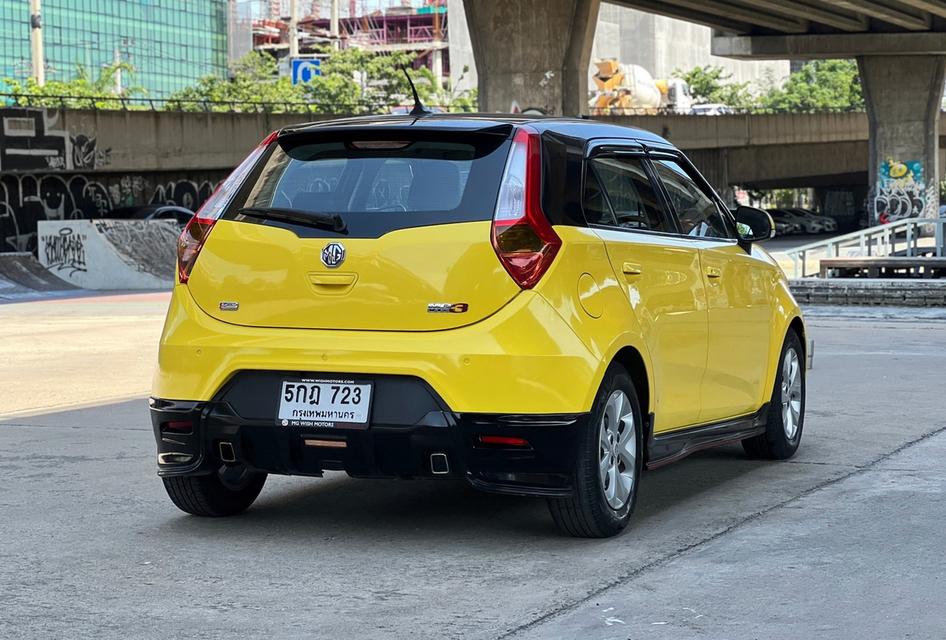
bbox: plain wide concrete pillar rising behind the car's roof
[463,0,600,115]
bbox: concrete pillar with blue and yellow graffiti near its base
[857,55,946,224]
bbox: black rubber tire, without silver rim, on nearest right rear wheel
[548,365,644,538]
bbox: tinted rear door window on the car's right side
[585,157,675,232]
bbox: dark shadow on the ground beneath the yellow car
[155,447,766,541]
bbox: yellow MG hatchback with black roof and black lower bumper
[151,114,806,537]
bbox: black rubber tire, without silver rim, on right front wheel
[742,330,806,460]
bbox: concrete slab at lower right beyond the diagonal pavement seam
[510,429,946,640]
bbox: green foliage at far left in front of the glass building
[4,62,145,109]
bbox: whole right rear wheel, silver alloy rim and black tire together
[549,365,643,538]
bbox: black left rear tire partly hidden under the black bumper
[162,467,266,518]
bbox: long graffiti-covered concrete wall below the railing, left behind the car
[0,108,332,251]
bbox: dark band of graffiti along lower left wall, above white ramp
[0,174,223,251]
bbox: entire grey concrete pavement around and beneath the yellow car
[0,300,946,639]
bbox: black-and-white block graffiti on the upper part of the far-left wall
[0,108,112,172]
